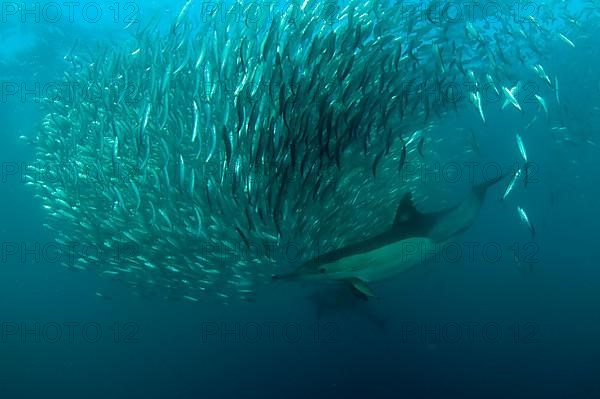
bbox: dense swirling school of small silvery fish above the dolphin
[28,0,576,302]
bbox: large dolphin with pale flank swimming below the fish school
[273,176,504,300]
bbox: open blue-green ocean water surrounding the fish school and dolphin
[0,2,600,398]
